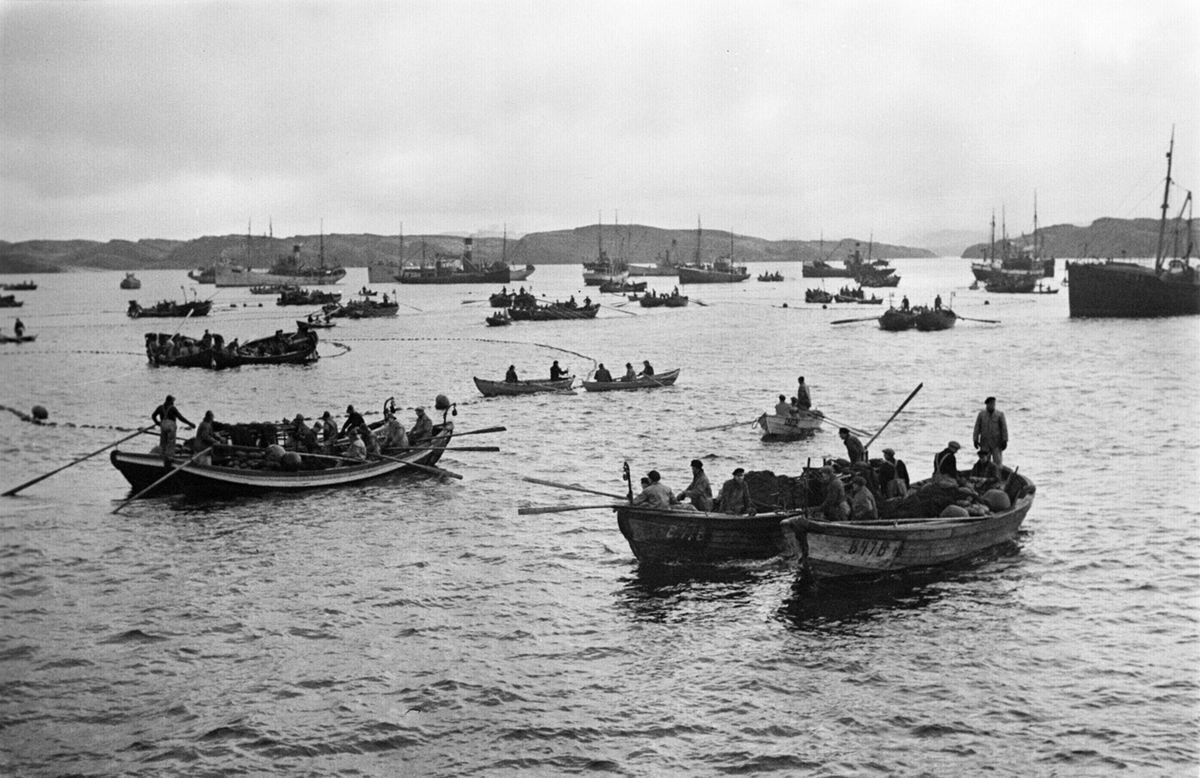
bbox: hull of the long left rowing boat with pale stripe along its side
[109,424,454,499]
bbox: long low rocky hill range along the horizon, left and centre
[0,225,932,274]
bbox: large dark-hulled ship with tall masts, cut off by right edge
[1063,132,1200,318]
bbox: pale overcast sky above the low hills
[0,0,1200,245]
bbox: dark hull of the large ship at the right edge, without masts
[1067,262,1200,318]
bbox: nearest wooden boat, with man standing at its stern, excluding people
[788,468,1037,579]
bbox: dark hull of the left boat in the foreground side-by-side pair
[617,505,793,564]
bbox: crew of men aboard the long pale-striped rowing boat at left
[150,395,433,467]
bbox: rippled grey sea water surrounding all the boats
[0,259,1200,776]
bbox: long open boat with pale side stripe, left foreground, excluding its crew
[109,421,454,499]
